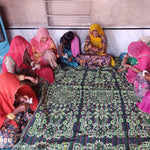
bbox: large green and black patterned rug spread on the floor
[15,59,150,150]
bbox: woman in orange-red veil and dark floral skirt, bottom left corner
[0,72,38,149]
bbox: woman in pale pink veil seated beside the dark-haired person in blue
[30,27,58,70]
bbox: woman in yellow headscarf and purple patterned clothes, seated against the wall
[77,24,115,68]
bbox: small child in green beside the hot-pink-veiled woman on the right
[117,53,138,73]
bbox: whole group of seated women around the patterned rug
[0,24,150,148]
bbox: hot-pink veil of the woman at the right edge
[126,41,150,84]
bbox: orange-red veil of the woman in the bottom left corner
[0,72,38,127]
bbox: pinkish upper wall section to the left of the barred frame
[0,0,47,28]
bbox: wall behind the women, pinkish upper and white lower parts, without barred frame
[0,0,150,56]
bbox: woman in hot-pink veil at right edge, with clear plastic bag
[125,41,150,113]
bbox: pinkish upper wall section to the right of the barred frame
[92,0,150,28]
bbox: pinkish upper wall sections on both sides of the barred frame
[0,0,150,28]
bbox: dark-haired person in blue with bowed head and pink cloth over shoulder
[60,31,80,67]
